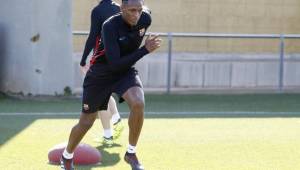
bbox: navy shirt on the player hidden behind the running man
[80,0,120,66]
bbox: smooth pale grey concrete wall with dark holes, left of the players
[0,0,73,94]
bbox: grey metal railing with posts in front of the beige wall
[73,31,300,94]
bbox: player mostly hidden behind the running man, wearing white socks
[80,0,124,146]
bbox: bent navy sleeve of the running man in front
[102,23,149,72]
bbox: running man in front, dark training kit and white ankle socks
[61,0,161,170]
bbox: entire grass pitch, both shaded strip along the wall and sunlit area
[0,94,300,170]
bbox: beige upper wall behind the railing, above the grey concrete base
[72,0,300,53]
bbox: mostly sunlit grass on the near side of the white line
[0,113,300,170]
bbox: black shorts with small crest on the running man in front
[82,68,143,113]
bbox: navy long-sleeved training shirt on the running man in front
[95,11,151,73]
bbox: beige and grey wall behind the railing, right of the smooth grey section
[72,0,300,93]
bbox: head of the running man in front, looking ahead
[121,0,144,26]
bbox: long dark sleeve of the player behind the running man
[80,9,101,66]
